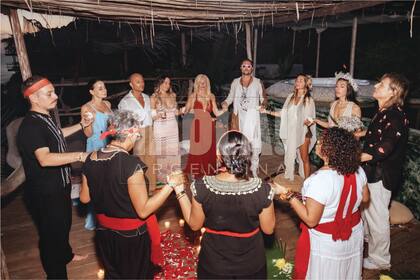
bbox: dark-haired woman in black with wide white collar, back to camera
[175,131,275,279]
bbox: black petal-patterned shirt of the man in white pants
[362,105,409,194]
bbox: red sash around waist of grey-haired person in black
[96,214,163,266]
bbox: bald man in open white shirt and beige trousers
[118,73,157,193]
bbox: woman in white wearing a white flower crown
[314,72,362,128]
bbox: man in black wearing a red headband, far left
[17,76,92,279]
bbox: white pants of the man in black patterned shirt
[362,181,391,269]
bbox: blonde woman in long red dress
[181,74,225,177]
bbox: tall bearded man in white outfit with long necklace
[222,59,267,177]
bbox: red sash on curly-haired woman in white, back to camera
[293,174,360,279]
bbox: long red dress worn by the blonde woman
[184,100,216,178]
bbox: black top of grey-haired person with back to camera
[82,150,147,218]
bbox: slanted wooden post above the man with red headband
[9,9,32,81]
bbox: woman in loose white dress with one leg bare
[261,74,316,180]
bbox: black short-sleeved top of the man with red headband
[17,111,70,194]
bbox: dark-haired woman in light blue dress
[81,79,112,230]
